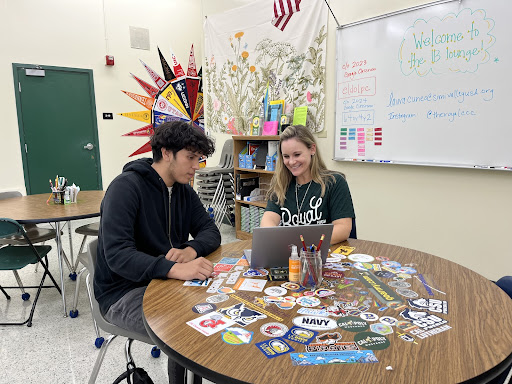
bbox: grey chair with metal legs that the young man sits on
[85,239,160,384]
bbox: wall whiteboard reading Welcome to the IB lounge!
[334,0,512,169]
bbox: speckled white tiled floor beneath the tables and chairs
[0,219,236,384]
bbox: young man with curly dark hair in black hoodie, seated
[94,121,220,383]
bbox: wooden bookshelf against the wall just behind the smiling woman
[233,136,279,240]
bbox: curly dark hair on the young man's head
[151,121,215,163]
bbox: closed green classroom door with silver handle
[12,63,102,195]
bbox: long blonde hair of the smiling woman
[267,125,343,206]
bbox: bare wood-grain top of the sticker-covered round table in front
[143,239,512,384]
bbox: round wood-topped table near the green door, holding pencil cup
[0,191,105,317]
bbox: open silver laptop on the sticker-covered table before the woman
[246,224,334,268]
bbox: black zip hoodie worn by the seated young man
[94,159,220,313]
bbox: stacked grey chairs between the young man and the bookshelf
[196,139,235,227]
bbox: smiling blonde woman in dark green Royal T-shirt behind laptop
[261,125,355,244]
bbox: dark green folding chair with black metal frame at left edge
[0,218,62,327]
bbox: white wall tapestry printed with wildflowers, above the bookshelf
[204,0,327,135]
